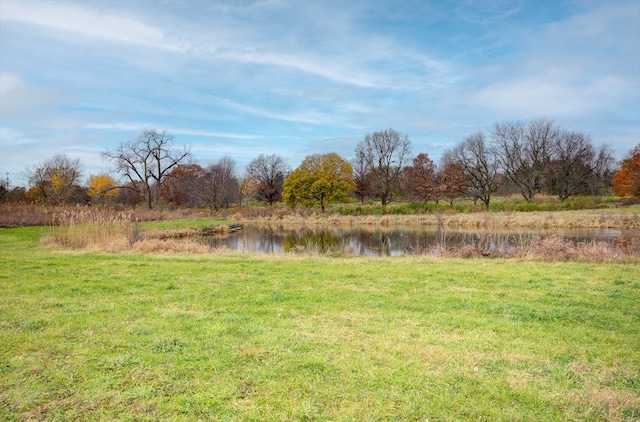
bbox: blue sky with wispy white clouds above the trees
[0,0,640,185]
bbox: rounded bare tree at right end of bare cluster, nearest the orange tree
[546,131,612,201]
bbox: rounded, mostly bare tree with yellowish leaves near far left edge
[26,153,83,204]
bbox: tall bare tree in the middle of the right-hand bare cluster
[493,118,562,202]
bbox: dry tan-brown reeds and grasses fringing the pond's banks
[0,204,640,262]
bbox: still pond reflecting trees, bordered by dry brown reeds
[203,225,637,256]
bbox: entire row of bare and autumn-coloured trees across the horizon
[0,118,640,211]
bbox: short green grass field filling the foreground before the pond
[0,228,640,421]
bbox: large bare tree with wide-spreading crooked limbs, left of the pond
[102,129,190,209]
